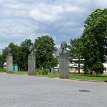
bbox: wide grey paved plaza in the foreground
[0,74,107,107]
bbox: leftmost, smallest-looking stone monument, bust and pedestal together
[6,47,13,73]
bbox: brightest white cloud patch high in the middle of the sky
[30,4,83,21]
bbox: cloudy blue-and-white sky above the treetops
[0,0,107,52]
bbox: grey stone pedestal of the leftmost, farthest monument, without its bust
[6,55,13,73]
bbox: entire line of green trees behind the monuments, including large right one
[0,9,107,73]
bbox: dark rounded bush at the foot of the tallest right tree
[92,62,104,74]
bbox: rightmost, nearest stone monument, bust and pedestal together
[59,42,69,79]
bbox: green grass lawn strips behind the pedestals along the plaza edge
[0,69,107,82]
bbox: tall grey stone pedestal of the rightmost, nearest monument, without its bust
[59,52,69,79]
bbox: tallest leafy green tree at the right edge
[81,9,107,72]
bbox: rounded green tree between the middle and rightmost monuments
[35,35,58,68]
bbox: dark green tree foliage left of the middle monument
[0,39,32,71]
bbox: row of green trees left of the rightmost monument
[0,35,58,71]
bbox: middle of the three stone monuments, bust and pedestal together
[28,45,36,75]
